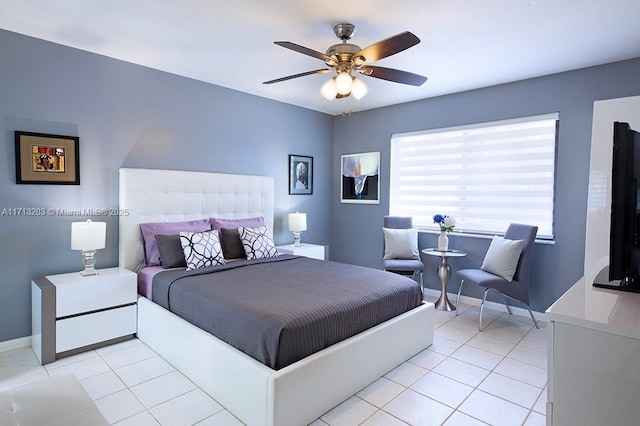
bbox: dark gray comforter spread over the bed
[152,255,421,370]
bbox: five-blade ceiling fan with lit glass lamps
[263,23,427,100]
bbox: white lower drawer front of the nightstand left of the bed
[56,305,137,353]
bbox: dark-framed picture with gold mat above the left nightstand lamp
[15,131,80,185]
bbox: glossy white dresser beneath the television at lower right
[547,279,640,426]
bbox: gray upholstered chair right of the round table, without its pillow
[454,223,539,331]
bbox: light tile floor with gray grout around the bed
[0,306,547,426]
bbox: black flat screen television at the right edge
[593,122,640,293]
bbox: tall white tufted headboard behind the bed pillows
[119,168,274,270]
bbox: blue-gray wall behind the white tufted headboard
[0,31,333,342]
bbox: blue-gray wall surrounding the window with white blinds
[331,59,640,312]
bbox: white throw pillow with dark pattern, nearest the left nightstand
[180,231,225,271]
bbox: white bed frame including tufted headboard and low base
[119,169,434,426]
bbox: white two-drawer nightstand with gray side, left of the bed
[31,268,138,364]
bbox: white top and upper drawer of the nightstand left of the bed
[47,268,137,318]
